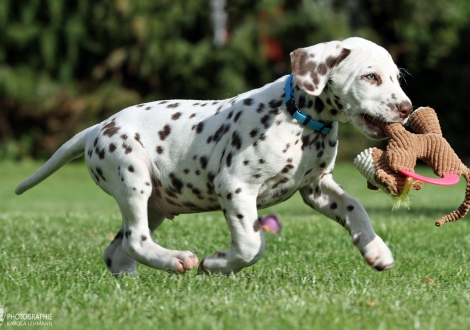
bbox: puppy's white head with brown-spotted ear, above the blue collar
[291,38,413,139]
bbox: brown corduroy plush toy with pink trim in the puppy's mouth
[354,107,470,227]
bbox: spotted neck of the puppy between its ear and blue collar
[292,79,344,123]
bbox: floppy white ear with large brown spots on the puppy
[290,41,351,96]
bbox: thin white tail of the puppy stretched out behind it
[15,125,96,195]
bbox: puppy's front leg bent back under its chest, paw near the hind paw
[198,181,265,274]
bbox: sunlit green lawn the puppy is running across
[0,163,470,330]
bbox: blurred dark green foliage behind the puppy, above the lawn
[0,0,470,159]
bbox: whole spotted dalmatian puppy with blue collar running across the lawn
[16,38,412,274]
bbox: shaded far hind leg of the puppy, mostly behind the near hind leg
[103,208,165,276]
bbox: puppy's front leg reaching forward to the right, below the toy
[300,173,393,271]
